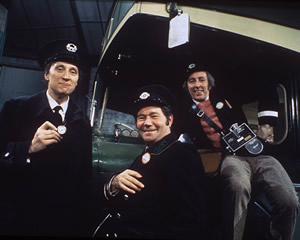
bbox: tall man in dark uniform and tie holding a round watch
[0,40,91,236]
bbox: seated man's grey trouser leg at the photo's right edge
[254,155,299,240]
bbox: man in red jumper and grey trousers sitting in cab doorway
[181,63,298,240]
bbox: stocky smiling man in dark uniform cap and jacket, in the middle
[99,85,206,239]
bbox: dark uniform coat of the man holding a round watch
[0,91,91,236]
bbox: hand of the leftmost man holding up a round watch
[28,121,62,153]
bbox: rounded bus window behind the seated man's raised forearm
[243,84,288,145]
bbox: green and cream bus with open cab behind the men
[89,1,300,239]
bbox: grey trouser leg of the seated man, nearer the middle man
[220,156,251,240]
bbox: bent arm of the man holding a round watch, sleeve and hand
[0,100,61,167]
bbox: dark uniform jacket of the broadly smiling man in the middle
[102,134,206,239]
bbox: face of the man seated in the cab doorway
[187,72,210,102]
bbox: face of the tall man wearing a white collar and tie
[44,62,79,99]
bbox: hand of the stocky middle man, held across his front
[111,169,144,194]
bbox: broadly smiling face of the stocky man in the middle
[136,106,173,145]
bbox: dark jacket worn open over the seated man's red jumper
[177,89,278,149]
